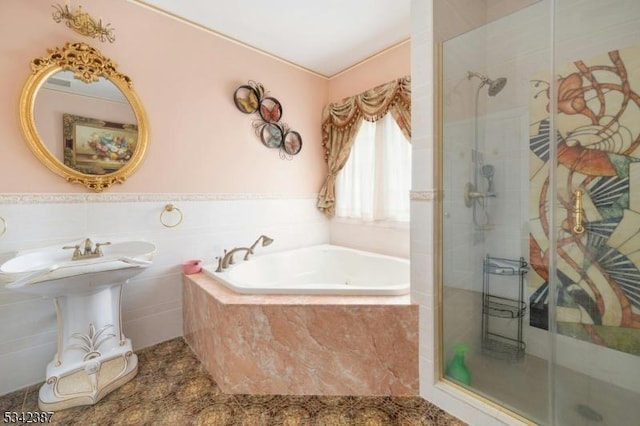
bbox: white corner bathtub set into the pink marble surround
[203,244,409,296]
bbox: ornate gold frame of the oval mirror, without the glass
[19,42,148,192]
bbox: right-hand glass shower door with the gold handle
[544,0,640,425]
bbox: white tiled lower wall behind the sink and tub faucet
[0,194,330,395]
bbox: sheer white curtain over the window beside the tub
[336,114,411,222]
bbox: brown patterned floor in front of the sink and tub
[0,338,464,426]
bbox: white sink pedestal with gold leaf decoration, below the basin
[38,284,138,411]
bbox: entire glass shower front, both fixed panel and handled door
[436,0,640,426]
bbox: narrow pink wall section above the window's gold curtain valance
[327,40,411,103]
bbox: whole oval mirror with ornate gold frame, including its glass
[20,43,148,192]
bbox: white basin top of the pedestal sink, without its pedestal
[0,241,156,296]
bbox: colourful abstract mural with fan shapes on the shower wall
[529,46,640,355]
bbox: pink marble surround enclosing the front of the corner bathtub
[183,274,418,395]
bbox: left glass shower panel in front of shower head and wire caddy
[440,1,552,424]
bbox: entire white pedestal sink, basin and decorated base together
[0,241,156,411]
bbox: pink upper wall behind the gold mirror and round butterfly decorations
[0,0,328,193]
